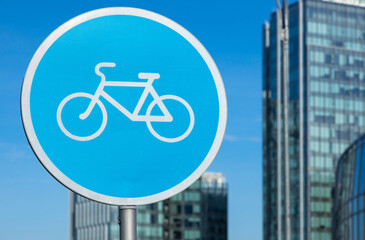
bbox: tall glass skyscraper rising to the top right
[263,0,365,240]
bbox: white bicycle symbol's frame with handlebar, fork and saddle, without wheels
[80,63,173,122]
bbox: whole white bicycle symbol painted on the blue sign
[57,62,194,143]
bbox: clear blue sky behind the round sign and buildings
[0,0,275,240]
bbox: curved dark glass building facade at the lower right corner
[332,135,365,240]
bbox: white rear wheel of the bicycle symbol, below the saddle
[146,95,195,143]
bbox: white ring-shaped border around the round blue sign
[21,7,227,206]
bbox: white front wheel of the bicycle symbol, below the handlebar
[57,92,107,141]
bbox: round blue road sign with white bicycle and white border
[21,8,227,205]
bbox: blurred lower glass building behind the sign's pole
[70,173,227,240]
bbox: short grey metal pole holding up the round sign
[118,206,137,240]
